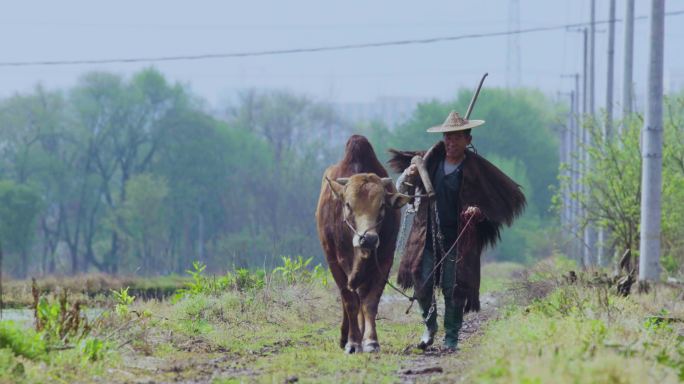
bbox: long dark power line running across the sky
[0,10,684,67]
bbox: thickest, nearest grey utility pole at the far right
[639,0,665,282]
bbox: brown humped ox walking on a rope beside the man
[316,135,409,353]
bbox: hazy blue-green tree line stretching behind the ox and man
[0,69,558,277]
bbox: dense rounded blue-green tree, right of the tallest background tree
[150,111,252,272]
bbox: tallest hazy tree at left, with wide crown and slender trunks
[71,69,188,273]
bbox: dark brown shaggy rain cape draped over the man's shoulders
[389,141,526,312]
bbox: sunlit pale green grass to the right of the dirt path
[447,258,684,383]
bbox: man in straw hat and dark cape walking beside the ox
[390,112,525,351]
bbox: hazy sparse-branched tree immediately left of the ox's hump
[228,90,350,268]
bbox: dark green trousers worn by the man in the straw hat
[418,249,463,348]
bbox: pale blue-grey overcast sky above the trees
[0,0,684,107]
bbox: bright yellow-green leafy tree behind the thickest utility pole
[562,95,684,274]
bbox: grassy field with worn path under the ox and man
[0,260,684,383]
